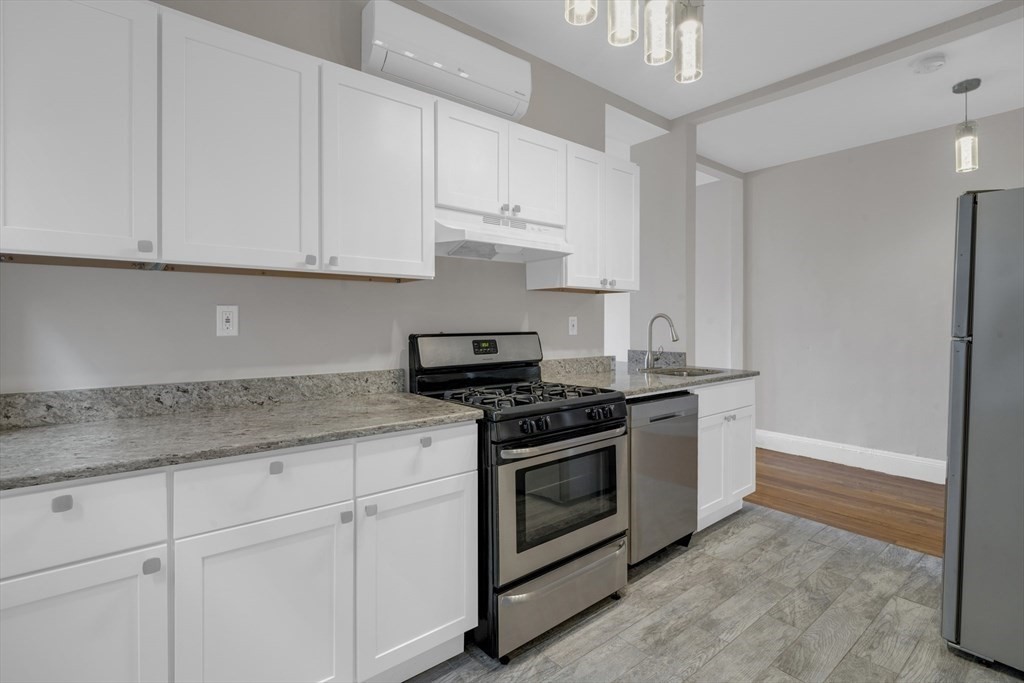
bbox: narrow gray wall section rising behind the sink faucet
[630,123,696,357]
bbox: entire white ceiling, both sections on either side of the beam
[422,0,1024,171]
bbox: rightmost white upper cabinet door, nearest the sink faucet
[604,159,640,292]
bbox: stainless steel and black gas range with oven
[409,332,629,661]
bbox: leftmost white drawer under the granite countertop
[0,474,167,578]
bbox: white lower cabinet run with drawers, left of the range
[0,423,477,683]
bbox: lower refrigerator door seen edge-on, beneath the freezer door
[942,339,971,643]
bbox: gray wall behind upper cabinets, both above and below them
[0,0,669,392]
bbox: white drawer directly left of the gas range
[355,424,477,496]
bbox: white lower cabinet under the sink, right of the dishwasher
[692,380,755,530]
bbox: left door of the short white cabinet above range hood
[437,100,509,216]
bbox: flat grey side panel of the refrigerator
[959,188,1024,669]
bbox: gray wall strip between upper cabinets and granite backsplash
[0,258,604,393]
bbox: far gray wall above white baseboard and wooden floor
[744,110,1024,460]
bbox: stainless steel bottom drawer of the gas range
[498,539,627,656]
